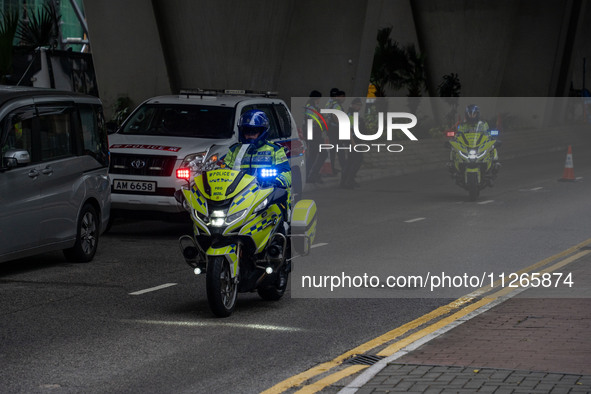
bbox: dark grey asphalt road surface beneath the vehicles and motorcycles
[0,145,591,393]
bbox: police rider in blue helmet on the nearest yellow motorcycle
[224,109,291,223]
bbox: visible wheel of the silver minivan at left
[64,204,99,263]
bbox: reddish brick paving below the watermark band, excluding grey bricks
[397,298,591,375]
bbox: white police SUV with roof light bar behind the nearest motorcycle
[109,90,306,217]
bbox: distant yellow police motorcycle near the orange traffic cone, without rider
[448,130,500,201]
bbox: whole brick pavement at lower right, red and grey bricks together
[346,255,591,394]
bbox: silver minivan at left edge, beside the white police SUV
[0,85,111,262]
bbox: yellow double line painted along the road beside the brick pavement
[263,238,591,394]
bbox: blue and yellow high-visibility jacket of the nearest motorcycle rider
[224,141,291,191]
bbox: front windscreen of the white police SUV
[119,104,234,139]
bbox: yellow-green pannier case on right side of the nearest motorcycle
[291,200,317,255]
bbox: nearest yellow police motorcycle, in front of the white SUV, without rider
[175,169,316,317]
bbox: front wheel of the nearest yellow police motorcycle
[205,256,238,317]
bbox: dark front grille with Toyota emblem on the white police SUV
[109,153,177,176]
